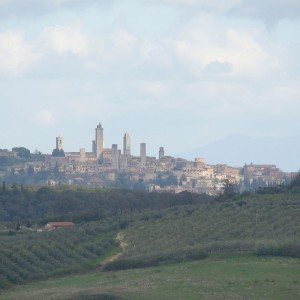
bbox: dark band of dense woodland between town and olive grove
[0,185,211,222]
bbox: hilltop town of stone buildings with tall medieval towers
[0,124,295,195]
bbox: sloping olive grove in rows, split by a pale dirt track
[0,193,300,290]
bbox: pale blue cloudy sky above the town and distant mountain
[0,0,300,166]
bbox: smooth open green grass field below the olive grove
[0,254,300,300]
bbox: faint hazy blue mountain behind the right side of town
[178,135,300,172]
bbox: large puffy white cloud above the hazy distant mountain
[173,16,277,76]
